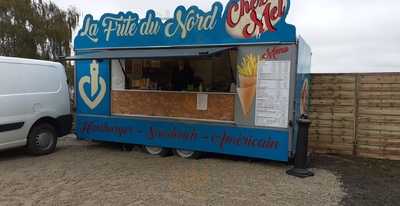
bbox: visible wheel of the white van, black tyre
[28,123,58,155]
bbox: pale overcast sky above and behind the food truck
[52,0,400,73]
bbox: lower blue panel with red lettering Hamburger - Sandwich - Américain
[76,115,288,161]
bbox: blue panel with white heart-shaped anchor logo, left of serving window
[75,60,110,115]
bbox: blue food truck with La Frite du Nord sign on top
[67,0,311,162]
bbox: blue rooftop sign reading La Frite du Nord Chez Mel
[75,0,296,50]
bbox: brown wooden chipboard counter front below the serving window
[112,91,235,121]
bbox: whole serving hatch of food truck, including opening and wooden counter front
[112,50,237,122]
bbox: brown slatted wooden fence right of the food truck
[309,73,400,160]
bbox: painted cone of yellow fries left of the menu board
[238,54,258,118]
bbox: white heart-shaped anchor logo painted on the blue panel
[79,60,107,110]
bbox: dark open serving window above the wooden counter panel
[116,50,236,93]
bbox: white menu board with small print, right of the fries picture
[255,61,290,128]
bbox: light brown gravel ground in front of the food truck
[0,137,345,206]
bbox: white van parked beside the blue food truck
[0,56,72,155]
